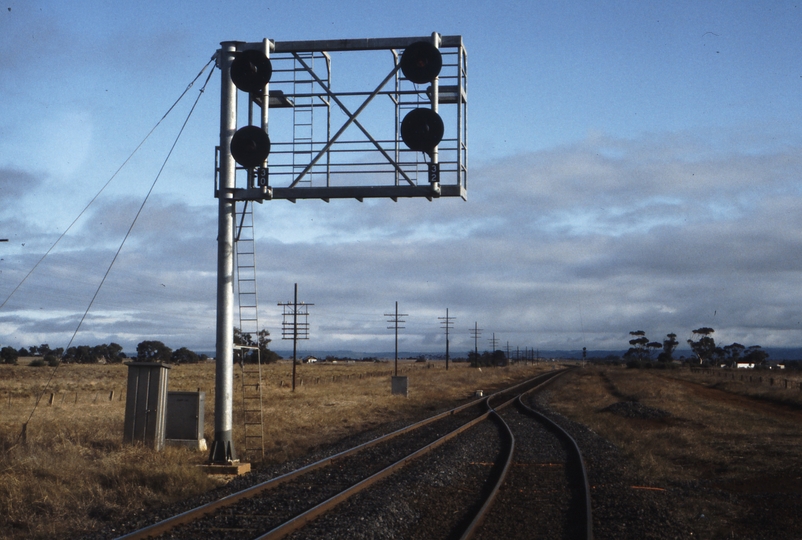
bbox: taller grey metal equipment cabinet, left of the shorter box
[123,362,170,451]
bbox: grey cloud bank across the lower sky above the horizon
[0,130,802,353]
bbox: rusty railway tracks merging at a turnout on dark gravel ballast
[114,372,591,540]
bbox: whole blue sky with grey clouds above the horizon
[0,0,802,354]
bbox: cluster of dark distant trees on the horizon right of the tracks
[624,326,769,367]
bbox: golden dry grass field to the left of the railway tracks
[0,361,553,539]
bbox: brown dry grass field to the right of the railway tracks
[550,368,802,538]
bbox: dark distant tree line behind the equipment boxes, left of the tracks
[0,328,281,366]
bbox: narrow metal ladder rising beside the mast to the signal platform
[234,201,265,458]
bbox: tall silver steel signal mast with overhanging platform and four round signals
[209,33,468,464]
